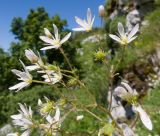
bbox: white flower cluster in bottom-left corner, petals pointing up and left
[11,103,34,136]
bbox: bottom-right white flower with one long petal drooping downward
[115,82,153,130]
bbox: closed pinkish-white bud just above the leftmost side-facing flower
[25,49,39,63]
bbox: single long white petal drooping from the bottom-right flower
[133,105,153,130]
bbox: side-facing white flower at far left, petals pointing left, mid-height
[9,60,32,91]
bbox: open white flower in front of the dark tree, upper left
[40,24,71,50]
